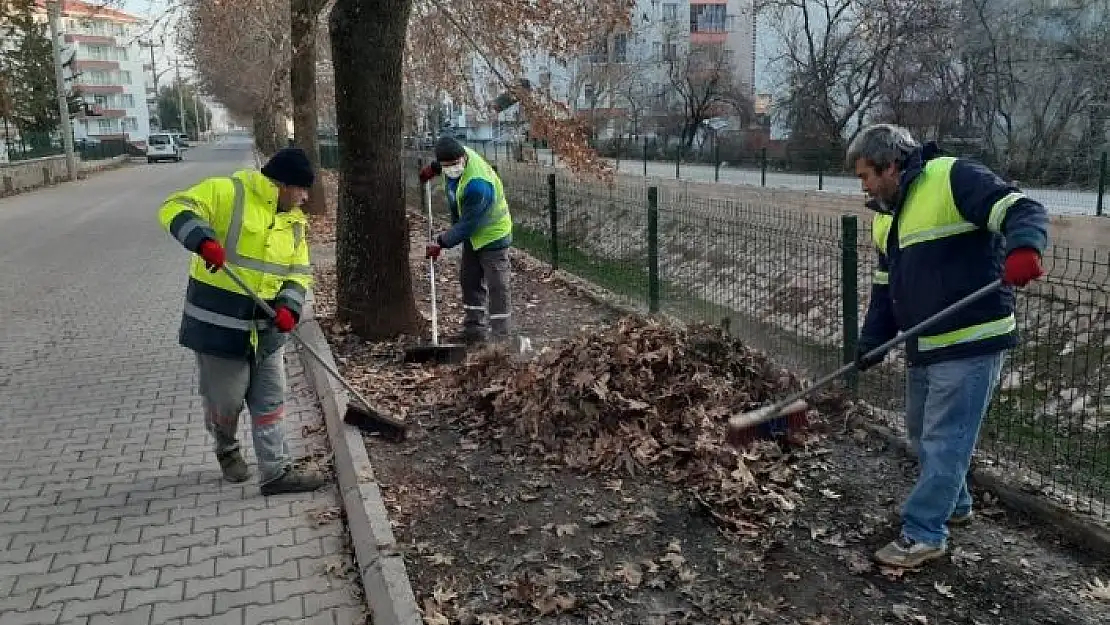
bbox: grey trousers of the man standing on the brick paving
[196,347,293,484]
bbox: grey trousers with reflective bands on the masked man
[458,241,512,339]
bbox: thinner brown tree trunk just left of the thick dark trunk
[289,0,327,214]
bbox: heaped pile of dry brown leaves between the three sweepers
[441,319,844,536]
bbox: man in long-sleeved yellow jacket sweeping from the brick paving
[159,148,327,495]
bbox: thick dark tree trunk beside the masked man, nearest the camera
[330,0,423,340]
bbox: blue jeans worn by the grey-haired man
[902,352,1005,545]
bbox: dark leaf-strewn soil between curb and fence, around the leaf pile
[314,199,1110,625]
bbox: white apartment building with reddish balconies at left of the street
[52,0,150,144]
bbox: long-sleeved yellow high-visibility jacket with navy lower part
[159,170,312,359]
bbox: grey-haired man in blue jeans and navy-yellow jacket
[847,124,1048,567]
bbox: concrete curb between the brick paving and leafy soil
[297,302,423,625]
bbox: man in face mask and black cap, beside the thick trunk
[420,137,513,344]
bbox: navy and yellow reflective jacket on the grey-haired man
[860,143,1048,365]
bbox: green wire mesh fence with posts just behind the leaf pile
[405,147,1110,515]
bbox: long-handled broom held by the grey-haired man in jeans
[727,280,1002,445]
